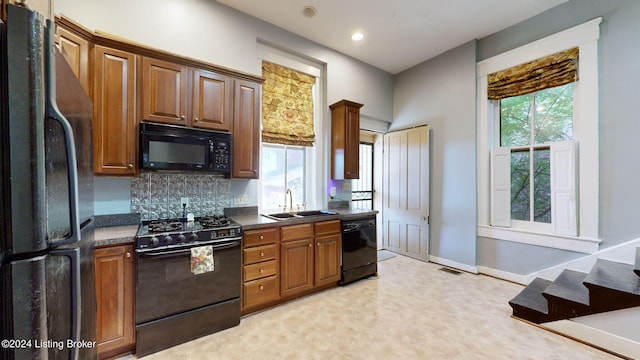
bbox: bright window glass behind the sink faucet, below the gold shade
[261,144,307,209]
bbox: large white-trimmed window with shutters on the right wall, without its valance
[477,18,602,253]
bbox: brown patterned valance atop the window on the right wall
[487,48,578,100]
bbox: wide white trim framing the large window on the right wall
[476,17,602,253]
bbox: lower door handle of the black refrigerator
[50,248,82,360]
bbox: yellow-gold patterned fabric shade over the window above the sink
[262,61,316,146]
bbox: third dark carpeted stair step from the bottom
[584,259,640,313]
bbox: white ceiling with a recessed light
[217,0,568,74]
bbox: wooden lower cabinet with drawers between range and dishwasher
[242,220,342,315]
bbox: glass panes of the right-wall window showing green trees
[497,83,575,232]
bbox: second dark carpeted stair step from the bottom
[542,269,591,319]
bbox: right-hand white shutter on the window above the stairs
[551,140,578,236]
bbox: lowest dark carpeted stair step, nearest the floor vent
[509,278,551,324]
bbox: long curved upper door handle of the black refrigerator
[44,19,81,246]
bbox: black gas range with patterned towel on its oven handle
[135,216,242,357]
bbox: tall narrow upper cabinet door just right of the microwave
[231,80,261,179]
